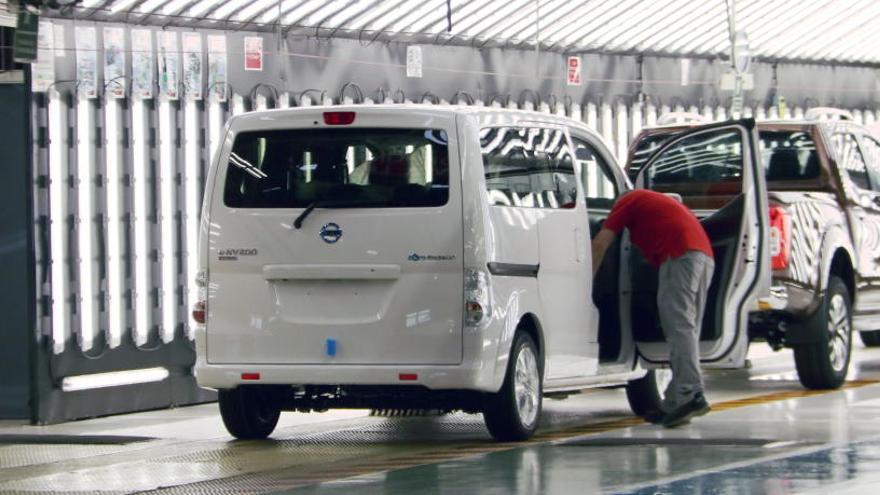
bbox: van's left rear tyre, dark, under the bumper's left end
[218,387,281,440]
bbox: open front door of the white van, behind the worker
[622,119,771,367]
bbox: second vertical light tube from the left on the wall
[76,98,98,351]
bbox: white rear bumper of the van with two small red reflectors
[195,360,497,392]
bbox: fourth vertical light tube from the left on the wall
[131,98,152,346]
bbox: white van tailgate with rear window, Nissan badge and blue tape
[206,107,463,365]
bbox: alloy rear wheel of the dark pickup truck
[794,275,852,389]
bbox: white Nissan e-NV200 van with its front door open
[193,105,759,440]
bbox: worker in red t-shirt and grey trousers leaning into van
[592,189,715,428]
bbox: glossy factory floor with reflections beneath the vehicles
[0,348,880,495]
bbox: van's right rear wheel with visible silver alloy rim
[483,332,543,442]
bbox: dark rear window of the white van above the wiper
[223,128,449,208]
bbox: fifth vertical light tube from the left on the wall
[158,98,177,343]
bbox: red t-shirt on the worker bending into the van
[603,189,712,267]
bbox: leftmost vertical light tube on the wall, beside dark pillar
[49,90,70,354]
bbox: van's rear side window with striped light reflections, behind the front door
[480,127,577,209]
